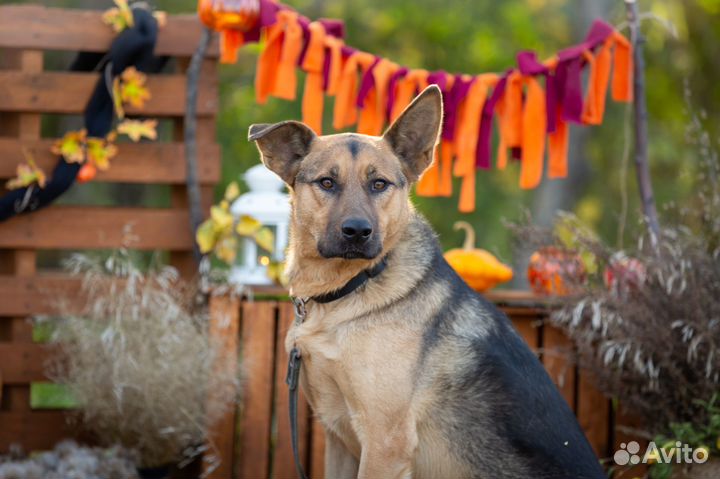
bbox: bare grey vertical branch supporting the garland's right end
[625,0,660,245]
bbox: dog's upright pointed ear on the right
[383,85,443,182]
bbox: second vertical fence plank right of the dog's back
[542,323,575,411]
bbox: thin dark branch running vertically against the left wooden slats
[185,28,212,265]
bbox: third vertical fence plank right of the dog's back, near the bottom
[577,369,613,457]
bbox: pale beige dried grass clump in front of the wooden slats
[45,250,240,466]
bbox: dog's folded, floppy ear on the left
[248,121,316,186]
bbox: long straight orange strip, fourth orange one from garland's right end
[520,77,547,189]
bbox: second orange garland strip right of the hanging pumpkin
[272,10,303,100]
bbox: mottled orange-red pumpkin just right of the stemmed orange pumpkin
[528,246,585,296]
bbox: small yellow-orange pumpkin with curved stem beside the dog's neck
[444,221,513,291]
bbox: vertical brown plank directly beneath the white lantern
[236,301,276,478]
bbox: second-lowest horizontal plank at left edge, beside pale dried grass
[0,342,51,385]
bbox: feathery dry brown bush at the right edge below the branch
[511,113,720,438]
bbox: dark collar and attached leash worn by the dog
[285,256,387,479]
